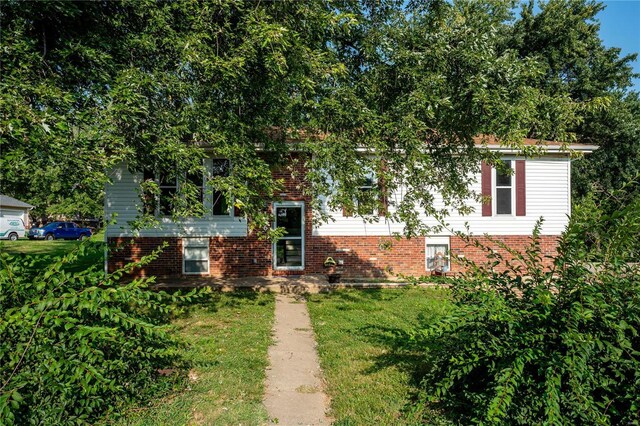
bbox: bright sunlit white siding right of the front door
[313,156,571,236]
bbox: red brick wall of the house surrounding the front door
[108,154,557,277]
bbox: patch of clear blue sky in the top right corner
[598,0,640,91]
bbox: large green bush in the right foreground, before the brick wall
[415,199,640,425]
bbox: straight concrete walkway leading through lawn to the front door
[264,294,331,426]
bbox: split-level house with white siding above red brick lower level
[105,140,597,276]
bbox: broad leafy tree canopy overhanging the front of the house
[0,0,596,234]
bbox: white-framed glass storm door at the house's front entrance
[273,201,304,270]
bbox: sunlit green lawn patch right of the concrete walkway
[308,288,451,425]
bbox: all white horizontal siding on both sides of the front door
[105,156,571,237]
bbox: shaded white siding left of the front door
[105,162,247,237]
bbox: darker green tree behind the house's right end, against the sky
[508,0,640,198]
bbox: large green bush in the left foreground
[0,243,195,425]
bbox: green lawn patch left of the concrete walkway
[116,292,274,426]
